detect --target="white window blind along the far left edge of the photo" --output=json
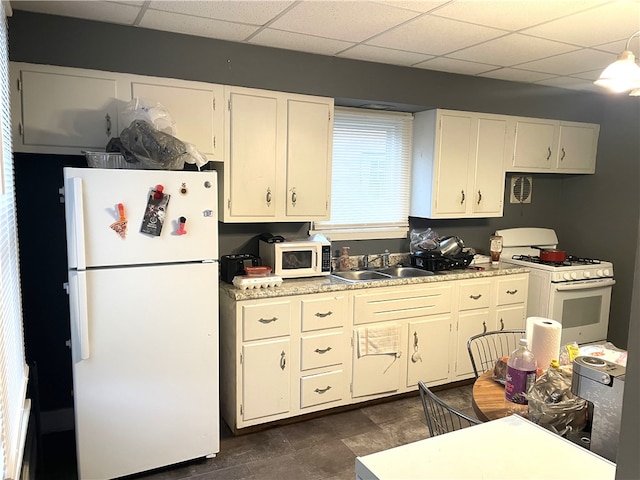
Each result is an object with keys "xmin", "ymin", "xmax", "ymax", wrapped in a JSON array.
[{"xmin": 0, "ymin": 2, "xmax": 29, "ymax": 479}]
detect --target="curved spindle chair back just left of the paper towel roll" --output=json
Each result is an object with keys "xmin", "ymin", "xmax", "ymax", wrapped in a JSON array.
[{"xmin": 467, "ymin": 330, "xmax": 526, "ymax": 378}]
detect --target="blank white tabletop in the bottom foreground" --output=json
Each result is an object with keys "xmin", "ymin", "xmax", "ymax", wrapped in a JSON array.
[{"xmin": 356, "ymin": 415, "xmax": 616, "ymax": 480}]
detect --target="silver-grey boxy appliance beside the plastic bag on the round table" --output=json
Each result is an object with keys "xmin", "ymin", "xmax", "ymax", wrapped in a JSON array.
[{"xmin": 571, "ymin": 356, "xmax": 626, "ymax": 462}]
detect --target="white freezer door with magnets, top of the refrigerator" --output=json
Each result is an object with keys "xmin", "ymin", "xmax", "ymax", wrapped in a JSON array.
[{"xmin": 64, "ymin": 168, "xmax": 218, "ymax": 269}]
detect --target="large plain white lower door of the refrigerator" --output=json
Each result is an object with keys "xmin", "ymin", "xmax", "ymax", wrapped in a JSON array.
[{"xmin": 69, "ymin": 262, "xmax": 220, "ymax": 480}]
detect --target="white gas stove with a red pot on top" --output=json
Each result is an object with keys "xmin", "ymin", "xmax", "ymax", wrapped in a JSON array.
[{"xmin": 496, "ymin": 228, "xmax": 616, "ymax": 345}]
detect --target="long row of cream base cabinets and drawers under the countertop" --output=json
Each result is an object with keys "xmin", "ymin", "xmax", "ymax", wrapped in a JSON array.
[{"xmin": 220, "ymin": 272, "xmax": 529, "ymax": 431}]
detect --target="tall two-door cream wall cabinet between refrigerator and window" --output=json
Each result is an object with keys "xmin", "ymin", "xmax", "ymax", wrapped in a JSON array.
[{"xmin": 220, "ymin": 87, "xmax": 333, "ymax": 222}]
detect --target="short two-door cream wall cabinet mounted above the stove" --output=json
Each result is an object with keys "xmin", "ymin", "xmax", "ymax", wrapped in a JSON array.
[{"xmin": 505, "ymin": 117, "xmax": 600, "ymax": 173}]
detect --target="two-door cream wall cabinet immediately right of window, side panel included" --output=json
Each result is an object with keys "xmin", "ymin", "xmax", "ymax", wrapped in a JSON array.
[{"xmin": 410, "ymin": 110, "xmax": 507, "ymax": 218}]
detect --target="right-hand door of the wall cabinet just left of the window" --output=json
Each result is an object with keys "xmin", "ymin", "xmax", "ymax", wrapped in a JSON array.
[{"xmin": 286, "ymin": 97, "xmax": 333, "ymax": 221}]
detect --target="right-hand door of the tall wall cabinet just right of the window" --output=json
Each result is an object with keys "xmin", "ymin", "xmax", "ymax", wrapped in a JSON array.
[{"xmin": 471, "ymin": 117, "xmax": 507, "ymax": 217}]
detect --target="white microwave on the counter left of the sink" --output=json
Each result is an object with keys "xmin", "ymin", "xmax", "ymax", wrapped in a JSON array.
[{"xmin": 259, "ymin": 237, "xmax": 331, "ymax": 278}]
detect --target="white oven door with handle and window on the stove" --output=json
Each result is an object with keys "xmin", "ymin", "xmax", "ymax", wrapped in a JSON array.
[{"xmin": 549, "ymin": 278, "xmax": 616, "ymax": 345}]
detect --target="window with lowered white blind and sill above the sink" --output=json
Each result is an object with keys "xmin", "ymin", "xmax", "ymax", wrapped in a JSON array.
[{"xmin": 312, "ymin": 107, "xmax": 413, "ymax": 240}]
